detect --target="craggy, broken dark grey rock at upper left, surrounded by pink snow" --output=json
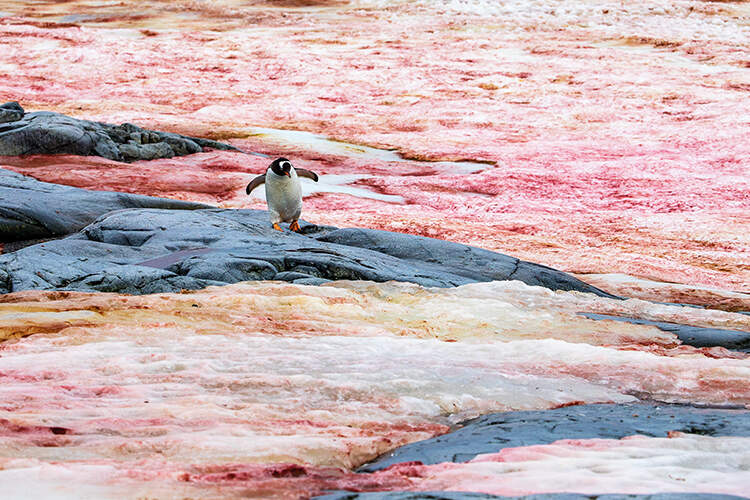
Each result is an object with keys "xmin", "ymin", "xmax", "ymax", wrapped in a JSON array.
[{"xmin": 0, "ymin": 102, "xmax": 235, "ymax": 162}]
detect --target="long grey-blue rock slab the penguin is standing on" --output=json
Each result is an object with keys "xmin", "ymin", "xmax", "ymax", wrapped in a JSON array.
[{"xmin": 0, "ymin": 199, "xmax": 607, "ymax": 296}]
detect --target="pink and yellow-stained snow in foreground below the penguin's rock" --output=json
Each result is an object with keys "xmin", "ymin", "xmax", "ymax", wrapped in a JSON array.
[{"xmin": 0, "ymin": 282, "xmax": 750, "ymax": 498}]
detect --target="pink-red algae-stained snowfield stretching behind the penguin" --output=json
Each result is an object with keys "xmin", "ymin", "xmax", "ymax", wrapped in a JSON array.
[{"xmin": 0, "ymin": 0, "xmax": 750, "ymax": 291}]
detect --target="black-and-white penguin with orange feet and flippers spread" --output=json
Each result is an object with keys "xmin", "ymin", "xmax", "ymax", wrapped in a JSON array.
[{"xmin": 245, "ymin": 158, "xmax": 318, "ymax": 233}]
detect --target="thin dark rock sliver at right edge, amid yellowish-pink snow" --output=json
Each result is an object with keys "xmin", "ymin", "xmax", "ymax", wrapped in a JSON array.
[{"xmin": 579, "ymin": 313, "xmax": 750, "ymax": 352}]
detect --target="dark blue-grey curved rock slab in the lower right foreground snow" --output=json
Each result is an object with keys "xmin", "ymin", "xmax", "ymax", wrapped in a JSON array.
[{"xmin": 359, "ymin": 403, "xmax": 750, "ymax": 472}]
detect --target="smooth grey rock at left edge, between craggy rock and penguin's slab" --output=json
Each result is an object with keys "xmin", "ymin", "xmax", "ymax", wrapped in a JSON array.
[{"xmin": 0, "ymin": 169, "xmax": 208, "ymax": 242}]
